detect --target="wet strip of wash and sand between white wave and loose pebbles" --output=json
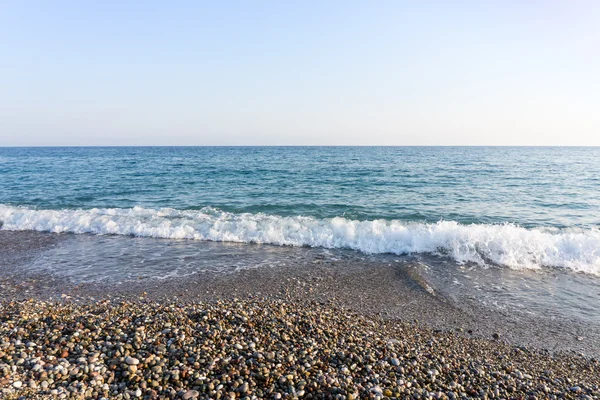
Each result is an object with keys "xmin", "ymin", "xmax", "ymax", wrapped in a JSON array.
[{"xmin": 0, "ymin": 231, "xmax": 600, "ymax": 355}]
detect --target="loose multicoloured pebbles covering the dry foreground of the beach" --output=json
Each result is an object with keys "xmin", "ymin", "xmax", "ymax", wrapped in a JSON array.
[{"xmin": 0, "ymin": 295, "xmax": 600, "ymax": 399}]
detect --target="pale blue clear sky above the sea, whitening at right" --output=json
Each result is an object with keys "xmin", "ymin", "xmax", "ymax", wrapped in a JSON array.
[{"xmin": 0, "ymin": 0, "xmax": 600, "ymax": 146}]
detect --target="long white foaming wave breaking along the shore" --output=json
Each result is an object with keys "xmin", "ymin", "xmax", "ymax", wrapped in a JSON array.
[{"xmin": 0, "ymin": 205, "xmax": 600, "ymax": 275}]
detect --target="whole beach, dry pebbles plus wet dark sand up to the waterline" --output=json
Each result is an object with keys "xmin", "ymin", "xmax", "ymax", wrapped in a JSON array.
[{"xmin": 0, "ymin": 232, "xmax": 600, "ymax": 399}]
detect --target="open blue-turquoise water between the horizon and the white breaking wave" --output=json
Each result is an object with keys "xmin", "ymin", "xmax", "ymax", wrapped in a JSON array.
[{"xmin": 0, "ymin": 147, "xmax": 600, "ymax": 228}]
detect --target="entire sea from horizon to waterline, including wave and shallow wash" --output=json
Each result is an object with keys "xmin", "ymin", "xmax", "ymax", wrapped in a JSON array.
[{"xmin": 0, "ymin": 147, "xmax": 600, "ymax": 326}]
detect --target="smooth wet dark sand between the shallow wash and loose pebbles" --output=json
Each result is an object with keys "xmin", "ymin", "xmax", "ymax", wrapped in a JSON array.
[{"xmin": 0, "ymin": 231, "xmax": 600, "ymax": 356}]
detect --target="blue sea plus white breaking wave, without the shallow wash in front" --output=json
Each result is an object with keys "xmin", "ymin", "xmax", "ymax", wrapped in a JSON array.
[{"xmin": 0, "ymin": 147, "xmax": 600, "ymax": 275}]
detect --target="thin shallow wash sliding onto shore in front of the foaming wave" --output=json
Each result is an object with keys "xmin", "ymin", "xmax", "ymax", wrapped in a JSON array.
[{"xmin": 0, "ymin": 232, "xmax": 600, "ymax": 326}]
